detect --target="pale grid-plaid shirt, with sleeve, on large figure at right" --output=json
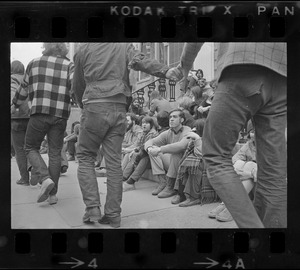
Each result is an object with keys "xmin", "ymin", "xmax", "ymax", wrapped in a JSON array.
[{"xmin": 181, "ymin": 42, "xmax": 287, "ymax": 79}]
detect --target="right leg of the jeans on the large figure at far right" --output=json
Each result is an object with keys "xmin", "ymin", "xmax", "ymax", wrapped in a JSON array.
[{"xmin": 254, "ymin": 72, "xmax": 287, "ymax": 228}]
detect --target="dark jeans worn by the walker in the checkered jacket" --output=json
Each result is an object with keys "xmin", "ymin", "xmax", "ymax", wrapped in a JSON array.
[{"xmin": 25, "ymin": 114, "xmax": 67, "ymax": 195}]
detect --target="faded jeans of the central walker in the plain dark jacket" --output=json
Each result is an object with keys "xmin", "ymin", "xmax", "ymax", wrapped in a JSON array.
[{"xmin": 77, "ymin": 103, "xmax": 127, "ymax": 217}]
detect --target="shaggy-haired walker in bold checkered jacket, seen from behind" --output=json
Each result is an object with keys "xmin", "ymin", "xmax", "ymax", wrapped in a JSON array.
[{"xmin": 11, "ymin": 43, "xmax": 73, "ymax": 204}]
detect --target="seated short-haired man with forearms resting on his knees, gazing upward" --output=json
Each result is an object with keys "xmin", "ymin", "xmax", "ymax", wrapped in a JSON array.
[{"xmin": 145, "ymin": 109, "xmax": 191, "ymax": 198}]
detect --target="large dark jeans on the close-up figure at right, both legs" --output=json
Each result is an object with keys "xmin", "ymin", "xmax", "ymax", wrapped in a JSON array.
[{"xmin": 203, "ymin": 65, "xmax": 287, "ymax": 228}]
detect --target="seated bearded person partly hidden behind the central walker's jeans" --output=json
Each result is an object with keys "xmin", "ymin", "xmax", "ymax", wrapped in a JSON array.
[{"xmin": 122, "ymin": 113, "xmax": 143, "ymax": 170}]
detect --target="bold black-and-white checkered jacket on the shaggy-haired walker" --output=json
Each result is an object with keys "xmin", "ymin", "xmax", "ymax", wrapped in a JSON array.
[{"xmin": 12, "ymin": 55, "xmax": 74, "ymax": 119}]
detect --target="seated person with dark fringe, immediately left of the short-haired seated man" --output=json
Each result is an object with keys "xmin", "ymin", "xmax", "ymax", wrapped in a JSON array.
[{"xmin": 123, "ymin": 116, "xmax": 157, "ymax": 192}]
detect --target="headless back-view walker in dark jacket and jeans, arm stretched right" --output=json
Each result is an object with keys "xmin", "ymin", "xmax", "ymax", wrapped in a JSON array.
[{"xmin": 73, "ymin": 43, "xmax": 180, "ymax": 227}]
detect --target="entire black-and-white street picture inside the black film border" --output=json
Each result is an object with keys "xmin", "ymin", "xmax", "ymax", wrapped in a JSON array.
[{"xmin": 10, "ymin": 42, "xmax": 288, "ymax": 229}]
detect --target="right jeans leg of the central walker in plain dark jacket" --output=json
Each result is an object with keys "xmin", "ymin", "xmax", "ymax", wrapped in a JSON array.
[{"xmin": 102, "ymin": 103, "xmax": 127, "ymax": 218}]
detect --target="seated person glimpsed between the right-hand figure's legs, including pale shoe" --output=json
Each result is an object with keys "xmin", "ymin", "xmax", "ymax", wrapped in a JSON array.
[{"xmin": 208, "ymin": 124, "xmax": 257, "ymax": 222}]
